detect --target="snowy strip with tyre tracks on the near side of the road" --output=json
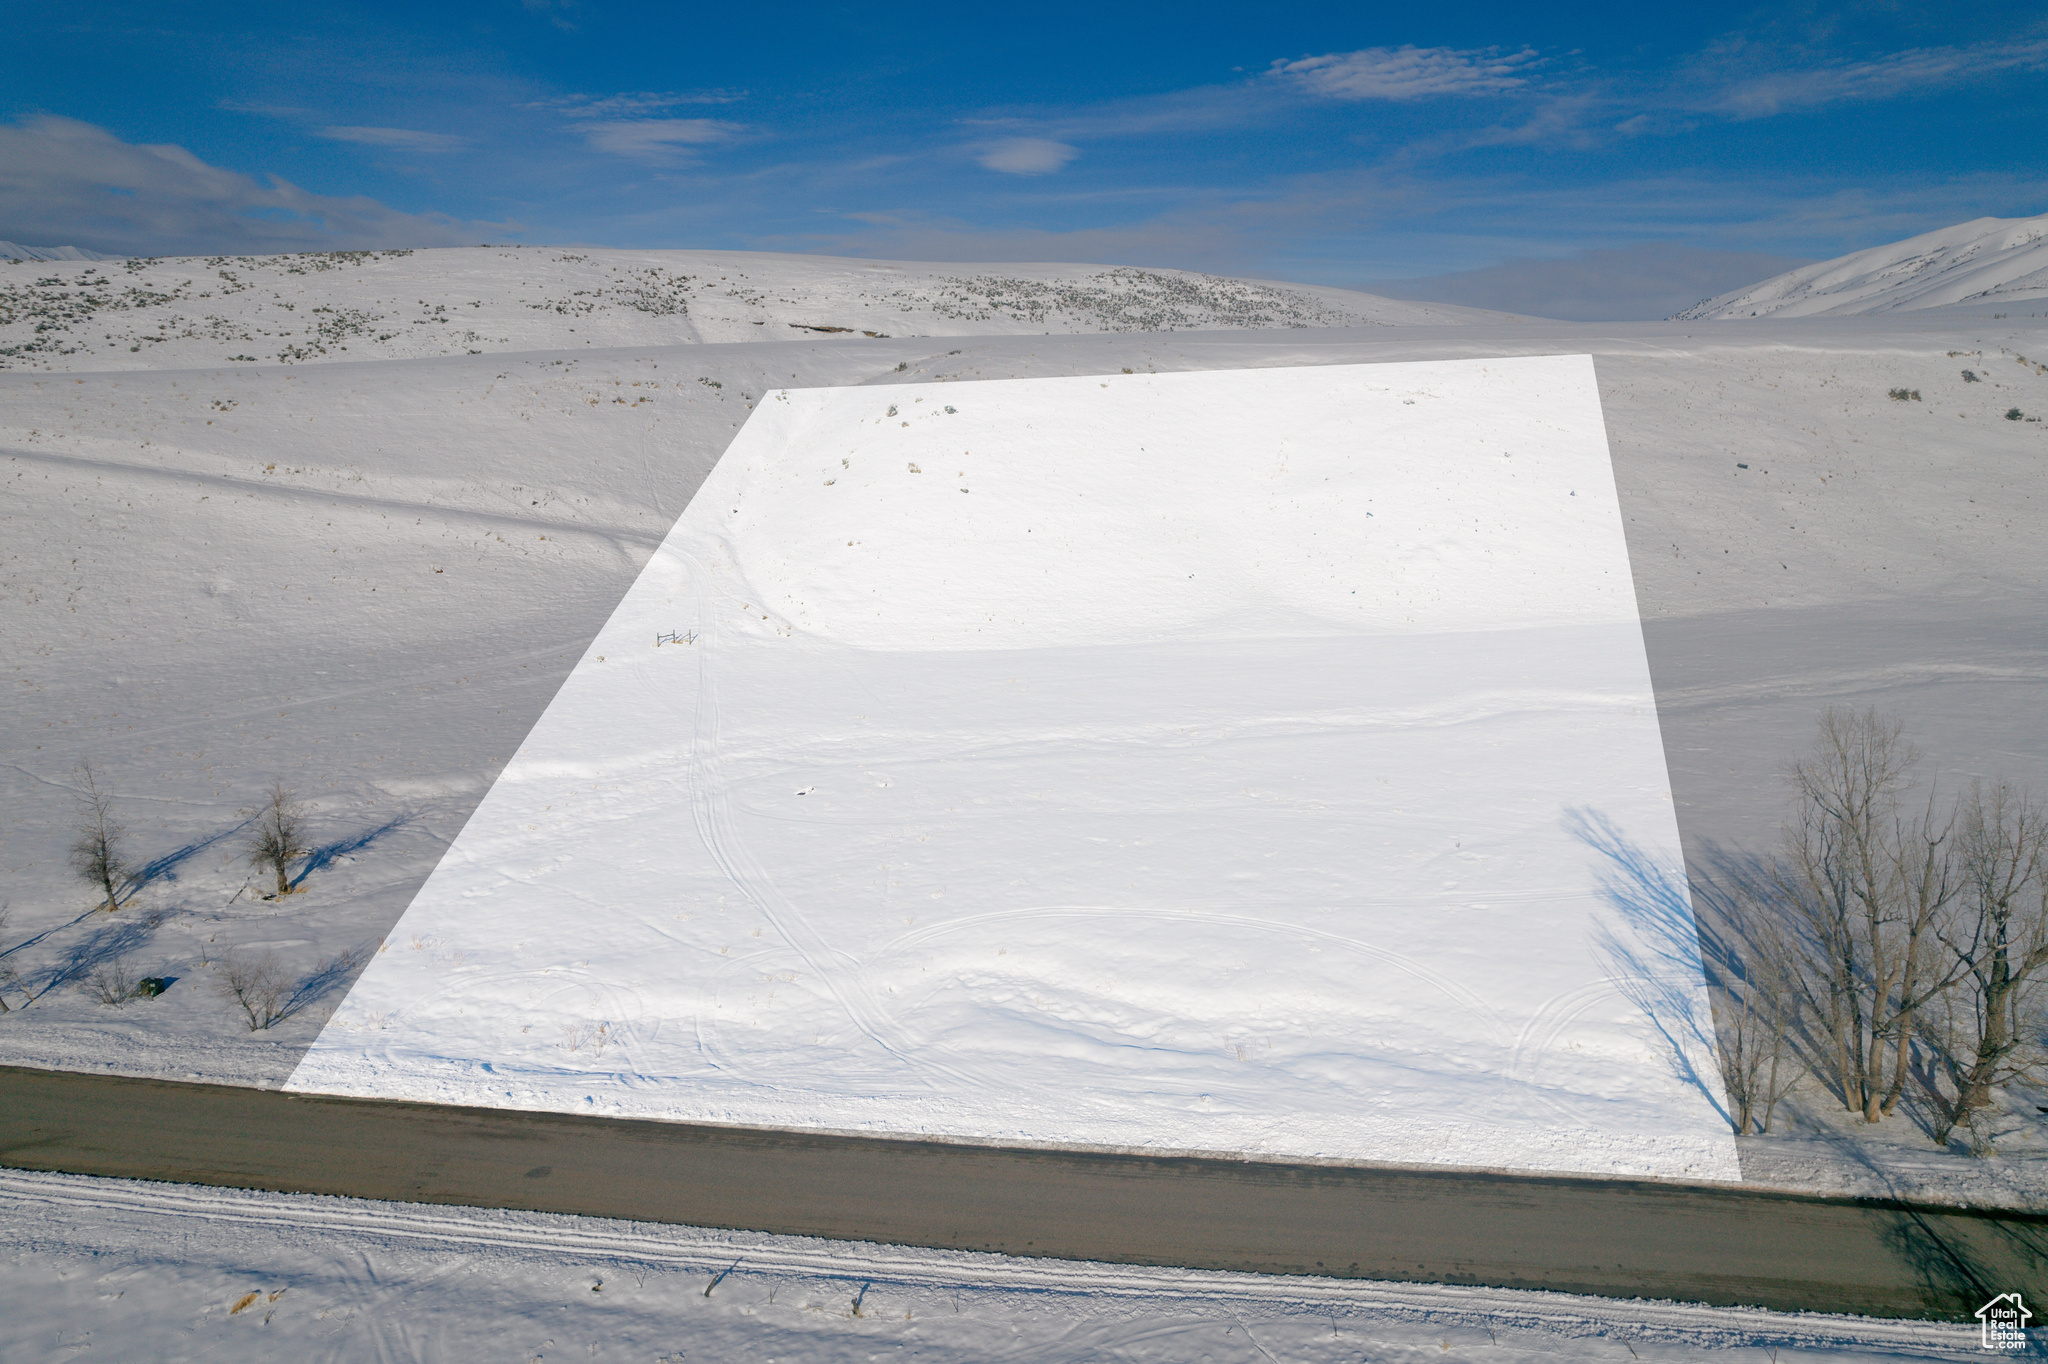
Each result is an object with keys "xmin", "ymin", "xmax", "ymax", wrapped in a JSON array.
[{"xmin": 0, "ymin": 1171, "xmax": 1985, "ymax": 1364}]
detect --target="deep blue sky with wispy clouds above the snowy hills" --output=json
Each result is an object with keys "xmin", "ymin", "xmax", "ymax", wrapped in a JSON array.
[{"xmin": 0, "ymin": 0, "xmax": 2048, "ymax": 315}]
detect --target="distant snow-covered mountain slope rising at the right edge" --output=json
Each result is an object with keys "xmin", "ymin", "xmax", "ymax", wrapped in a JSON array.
[{"xmin": 1673, "ymin": 215, "xmax": 2048, "ymax": 322}]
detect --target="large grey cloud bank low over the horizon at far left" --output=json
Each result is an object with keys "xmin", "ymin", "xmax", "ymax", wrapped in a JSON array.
[{"xmin": 0, "ymin": 117, "xmax": 477, "ymax": 256}]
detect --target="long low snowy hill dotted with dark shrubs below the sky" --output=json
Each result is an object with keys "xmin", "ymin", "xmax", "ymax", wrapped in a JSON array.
[{"xmin": 0, "ymin": 246, "xmax": 1513, "ymax": 371}]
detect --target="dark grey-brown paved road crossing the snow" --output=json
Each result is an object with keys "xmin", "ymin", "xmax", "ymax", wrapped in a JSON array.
[{"xmin": 0, "ymin": 1069, "xmax": 2048, "ymax": 1319}]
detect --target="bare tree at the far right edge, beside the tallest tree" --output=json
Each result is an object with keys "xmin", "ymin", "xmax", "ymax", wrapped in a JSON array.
[{"xmin": 1929, "ymin": 780, "xmax": 2048, "ymax": 1139}]
